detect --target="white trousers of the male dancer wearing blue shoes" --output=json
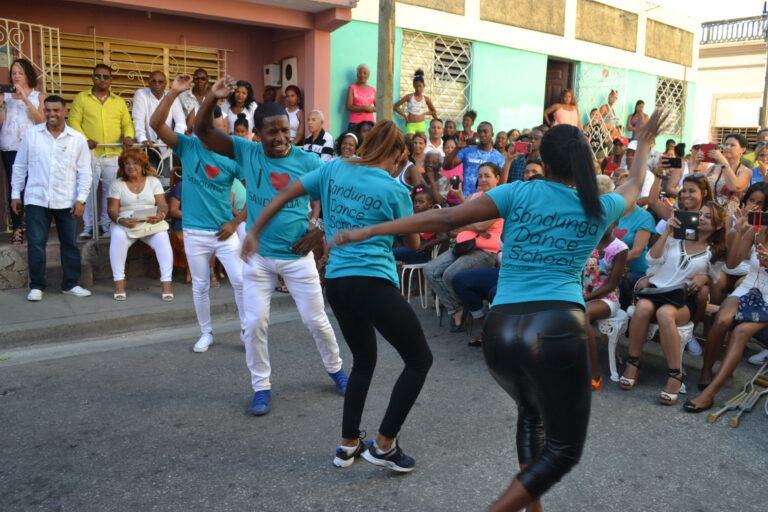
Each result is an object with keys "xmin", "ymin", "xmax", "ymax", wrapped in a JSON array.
[{"xmin": 243, "ymin": 253, "xmax": 341, "ymax": 391}]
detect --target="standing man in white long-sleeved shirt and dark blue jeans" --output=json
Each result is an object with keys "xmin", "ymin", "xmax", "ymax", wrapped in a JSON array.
[{"xmin": 11, "ymin": 95, "xmax": 92, "ymax": 301}]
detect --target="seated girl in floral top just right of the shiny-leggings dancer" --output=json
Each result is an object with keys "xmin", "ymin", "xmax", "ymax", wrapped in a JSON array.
[{"xmin": 581, "ymin": 222, "xmax": 629, "ymax": 391}]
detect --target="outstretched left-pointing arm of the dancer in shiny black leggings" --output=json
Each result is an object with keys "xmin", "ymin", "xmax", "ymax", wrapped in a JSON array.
[{"xmin": 334, "ymin": 195, "xmax": 500, "ymax": 245}]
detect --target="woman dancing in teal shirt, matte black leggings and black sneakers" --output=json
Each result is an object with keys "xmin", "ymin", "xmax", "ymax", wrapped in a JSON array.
[{"xmin": 243, "ymin": 121, "xmax": 432, "ymax": 473}]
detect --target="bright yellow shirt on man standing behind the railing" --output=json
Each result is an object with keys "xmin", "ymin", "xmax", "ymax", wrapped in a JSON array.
[{"xmin": 68, "ymin": 89, "xmax": 134, "ymax": 156}]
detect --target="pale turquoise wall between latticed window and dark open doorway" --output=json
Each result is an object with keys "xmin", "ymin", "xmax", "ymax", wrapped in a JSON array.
[{"xmin": 468, "ymin": 42, "xmax": 547, "ymax": 132}]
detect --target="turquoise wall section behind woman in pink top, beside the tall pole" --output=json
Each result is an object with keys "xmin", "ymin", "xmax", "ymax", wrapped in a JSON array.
[{"xmin": 326, "ymin": 21, "xmax": 405, "ymax": 137}]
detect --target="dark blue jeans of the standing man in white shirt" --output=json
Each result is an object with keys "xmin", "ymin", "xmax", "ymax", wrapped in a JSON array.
[{"xmin": 24, "ymin": 204, "xmax": 80, "ymax": 290}]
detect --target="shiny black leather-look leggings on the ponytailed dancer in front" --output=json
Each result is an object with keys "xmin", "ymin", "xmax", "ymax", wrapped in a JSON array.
[{"xmin": 483, "ymin": 301, "xmax": 592, "ymax": 499}]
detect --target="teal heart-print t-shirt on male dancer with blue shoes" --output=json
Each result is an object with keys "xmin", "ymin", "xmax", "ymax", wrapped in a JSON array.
[{"xmin": 232, "ymin": 137, "xmax": 323, "ymax": 260}]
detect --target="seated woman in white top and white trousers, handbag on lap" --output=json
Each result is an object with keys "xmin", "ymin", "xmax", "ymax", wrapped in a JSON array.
[{"xmin": 107, "ymin": 149, "xmax": 173, "ymax": 301}]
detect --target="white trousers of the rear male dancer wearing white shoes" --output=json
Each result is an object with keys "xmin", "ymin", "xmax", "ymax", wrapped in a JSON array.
[{"xmin": 184, "ymin": 229, "xmax": 243, "ymax": 334}]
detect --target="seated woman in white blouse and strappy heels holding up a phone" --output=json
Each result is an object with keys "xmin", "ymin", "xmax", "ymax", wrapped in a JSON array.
[{"xmin": 619, "ymin": 201, "xmax": 725, "ymax": 405}]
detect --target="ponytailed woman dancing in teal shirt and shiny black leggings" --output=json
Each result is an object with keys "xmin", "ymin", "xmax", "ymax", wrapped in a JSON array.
[{"xmin": 336, "ymin": 112, "xmax": 666, "ymax": 512}]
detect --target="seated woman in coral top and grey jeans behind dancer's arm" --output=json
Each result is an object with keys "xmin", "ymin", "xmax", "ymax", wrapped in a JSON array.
[{"xmin": 424, "ymin": 162, "xmax": 504, "ymax": 332}]
